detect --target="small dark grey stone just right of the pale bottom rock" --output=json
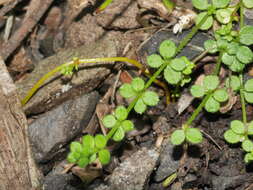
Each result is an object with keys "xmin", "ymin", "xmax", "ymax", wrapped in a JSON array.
[{"xmin": 154, "ymin": 143, "xmax": 179, "ymax": 182}]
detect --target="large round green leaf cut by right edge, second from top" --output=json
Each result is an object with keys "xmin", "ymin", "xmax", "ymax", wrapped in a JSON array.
[{"xmin": 239, "ymin": 25, "xmax": 253, "ymax": 46}]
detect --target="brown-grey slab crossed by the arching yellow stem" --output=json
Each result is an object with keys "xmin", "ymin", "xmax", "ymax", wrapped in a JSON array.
[{"xmin": 16, "ymin": 38, "xmax": 117, "ymax": 115}]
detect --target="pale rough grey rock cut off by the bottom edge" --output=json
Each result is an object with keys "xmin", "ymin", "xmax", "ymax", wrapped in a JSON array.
[{"xmin": 94, "ymin": 148, "xmax": 159, "ymax": 190}]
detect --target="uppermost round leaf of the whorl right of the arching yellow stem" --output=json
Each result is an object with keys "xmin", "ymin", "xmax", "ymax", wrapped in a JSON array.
[{"xmin": 159, "ymin": 40, "xmax": 177, "ymax": 59}]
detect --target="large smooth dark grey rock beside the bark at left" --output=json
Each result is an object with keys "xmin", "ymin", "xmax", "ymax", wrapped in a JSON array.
[{"xmin": 28, "ymin": 92, "xmax": 99, "ymax": 163}]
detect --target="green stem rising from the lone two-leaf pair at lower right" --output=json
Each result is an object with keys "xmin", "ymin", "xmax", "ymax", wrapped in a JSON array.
[{"xmin": 185, "ymin": 53, "xmax": 223, "ymax": 127}]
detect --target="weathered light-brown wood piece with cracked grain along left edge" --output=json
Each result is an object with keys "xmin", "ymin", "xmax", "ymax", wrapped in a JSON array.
[{"xmin": 0, "ymin": 59, "xmax": 40, "ymax": 190}]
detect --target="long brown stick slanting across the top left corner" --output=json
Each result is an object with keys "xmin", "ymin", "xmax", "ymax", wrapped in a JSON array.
[{"xmin": 0, "ymin": 0, "xmax": 54, "ymax": 60}]
